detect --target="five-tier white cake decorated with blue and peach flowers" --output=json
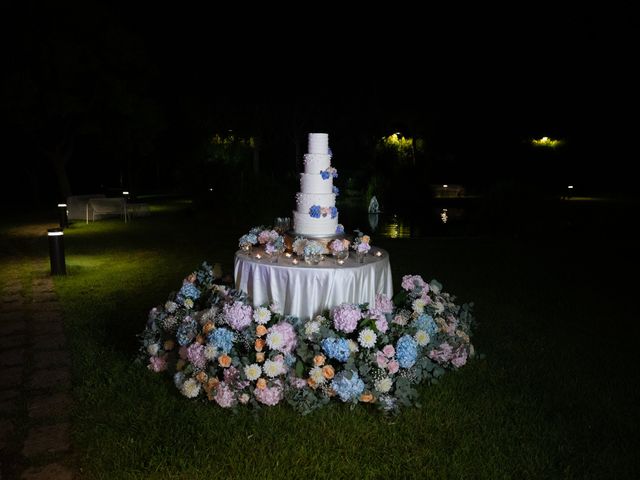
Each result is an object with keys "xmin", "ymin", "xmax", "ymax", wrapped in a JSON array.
[{"xmin": 293, "ymin": 133, "xmax": 338, "ymax": 236}]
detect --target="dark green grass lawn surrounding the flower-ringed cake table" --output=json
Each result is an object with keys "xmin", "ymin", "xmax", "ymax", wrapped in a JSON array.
[{"xmin": 0, "ymin": 197, "xmax": 640, "ymax": 479}]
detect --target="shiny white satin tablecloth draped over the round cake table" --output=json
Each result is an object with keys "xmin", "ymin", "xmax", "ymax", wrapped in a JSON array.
[{"xmin": 234, "ymin": 248, "xmax": 393, "ymax": 320}]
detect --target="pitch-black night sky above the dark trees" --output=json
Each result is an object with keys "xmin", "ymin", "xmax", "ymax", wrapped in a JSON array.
[{"xmin": 1, "ymin": 2, "xmax": 637, "ymax": 204}]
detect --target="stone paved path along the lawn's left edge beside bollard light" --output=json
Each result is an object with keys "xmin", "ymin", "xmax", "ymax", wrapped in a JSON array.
[{"xmin": 0, "ymin": 268, "xmax": 77, "ymax": 480}]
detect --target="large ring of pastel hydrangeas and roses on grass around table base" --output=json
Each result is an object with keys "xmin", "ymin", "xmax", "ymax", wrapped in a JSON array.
[{"xmin": 140, "ymin": 263, "xmax": 475, "ymax": 414}]
